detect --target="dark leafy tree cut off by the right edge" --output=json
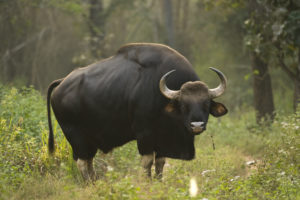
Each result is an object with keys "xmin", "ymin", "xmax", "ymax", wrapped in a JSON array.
[{"xmin": 270, "ymin": 0, "xmax": 300, "ymax": 111}]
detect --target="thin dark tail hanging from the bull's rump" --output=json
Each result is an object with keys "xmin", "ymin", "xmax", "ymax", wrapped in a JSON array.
[{"xmin": 47, "ymin": 79, "xmax": 63, "ymax": 154}]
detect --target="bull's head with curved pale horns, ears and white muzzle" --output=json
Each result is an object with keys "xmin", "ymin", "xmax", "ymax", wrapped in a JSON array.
[{"xmin": 159, "ymin": 67, "xmax": 227, "ymax": 134}]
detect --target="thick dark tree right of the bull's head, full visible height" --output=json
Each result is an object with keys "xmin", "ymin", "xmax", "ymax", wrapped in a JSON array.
[{"xmin": 245, "ymin": 1, "xmax": 275, "ymax": 123}]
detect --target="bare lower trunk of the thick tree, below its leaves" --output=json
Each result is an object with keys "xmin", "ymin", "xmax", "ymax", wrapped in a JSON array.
[{"xmin": 251, "ymin": 52, "xmax": 274, "ymax": 124}]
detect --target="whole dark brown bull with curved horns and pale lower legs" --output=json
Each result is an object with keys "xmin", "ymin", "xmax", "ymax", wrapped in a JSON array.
[{"xmin": 47, "ymin": 43, "xmax": 227, "ymax": 179}]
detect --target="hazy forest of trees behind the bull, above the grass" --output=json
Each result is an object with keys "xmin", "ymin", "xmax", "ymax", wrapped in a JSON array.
[{"xmin": 0, "ymin": 0, "xmax": 300, "ymax": 115}]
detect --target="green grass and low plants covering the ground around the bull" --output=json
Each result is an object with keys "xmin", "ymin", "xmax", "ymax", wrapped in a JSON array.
[{"xmin": 0, "ymin": 86, "xmax": 300, "ymax": 200}]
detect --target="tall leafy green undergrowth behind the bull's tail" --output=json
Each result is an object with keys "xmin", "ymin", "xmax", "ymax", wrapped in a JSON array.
[{"xmin": 0, "ymin": 85, "xmax": 72, "ymax": 198}]
